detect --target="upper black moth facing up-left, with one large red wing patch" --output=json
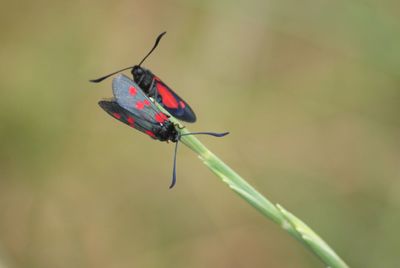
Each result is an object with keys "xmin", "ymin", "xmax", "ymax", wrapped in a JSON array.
[{"xmin": 90, "ymin": 32, "xmax": 196, "ymax": 123}]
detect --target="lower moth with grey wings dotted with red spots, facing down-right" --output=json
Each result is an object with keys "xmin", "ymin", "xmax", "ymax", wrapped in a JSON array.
[{"xmin": 99, "ymin": 75, "xmax": 228, "ymax": 188}]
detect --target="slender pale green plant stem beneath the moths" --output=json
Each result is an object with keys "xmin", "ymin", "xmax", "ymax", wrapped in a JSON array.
[{"xmin": 170, "ymin": 117, "xmax": 348, "ymax": 268}]
